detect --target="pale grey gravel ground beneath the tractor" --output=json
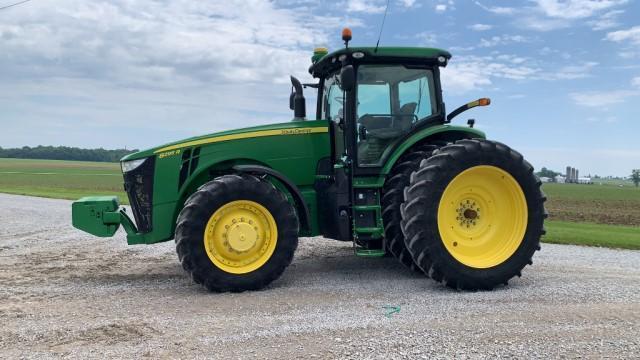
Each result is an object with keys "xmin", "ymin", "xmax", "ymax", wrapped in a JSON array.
[{"xmin": 0, "ymin": 194, "xmax": 640, "ymax": 359}]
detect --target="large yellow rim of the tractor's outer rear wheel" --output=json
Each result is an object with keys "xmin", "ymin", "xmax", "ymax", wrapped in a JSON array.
[{"xmin": 438, "ymin": 165, "xmax": 528, "ymax": 269}]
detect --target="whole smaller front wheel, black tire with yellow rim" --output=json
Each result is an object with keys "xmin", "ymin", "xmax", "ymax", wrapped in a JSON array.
[{"xmin": 176, "ymin": 175, "xmax": 299, "ymax": 292}]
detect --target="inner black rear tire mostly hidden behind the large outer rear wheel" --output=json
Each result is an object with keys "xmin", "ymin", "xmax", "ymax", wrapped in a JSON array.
[{"xmin": 381, "ymin": 143, "xmax": 444, "ymax": 272}]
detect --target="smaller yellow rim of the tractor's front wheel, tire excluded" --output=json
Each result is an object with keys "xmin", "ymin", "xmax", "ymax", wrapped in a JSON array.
[{"xmin": 204, "ymin": 200, "xmax": 278, "ymax": 274}]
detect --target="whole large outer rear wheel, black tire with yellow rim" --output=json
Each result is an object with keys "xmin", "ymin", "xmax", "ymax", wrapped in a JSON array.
[{"xmin": 401, "ymin": 140, "xmax": 546, "ymax": 290}]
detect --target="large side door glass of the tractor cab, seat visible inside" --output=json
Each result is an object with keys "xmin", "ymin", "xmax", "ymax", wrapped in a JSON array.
[{"xmin": 357, "ymin": 65, "xmax": 437, "ymax": 167}]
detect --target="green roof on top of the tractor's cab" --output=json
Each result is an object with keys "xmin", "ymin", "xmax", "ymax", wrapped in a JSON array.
[{"xmin": 309, "ymin": 47, "xmax": 451, "ymax": 77}]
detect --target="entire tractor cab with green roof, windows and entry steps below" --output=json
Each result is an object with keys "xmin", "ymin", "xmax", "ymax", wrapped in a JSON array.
[{"xmin": 290, "ymin": 33, "xmax": 472, "ymax": 256}]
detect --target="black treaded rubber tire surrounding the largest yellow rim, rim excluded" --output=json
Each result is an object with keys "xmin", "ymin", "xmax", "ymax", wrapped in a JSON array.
[{"xmin": 404, "ymin": 140, "xmax": 545, "ymax": 289}]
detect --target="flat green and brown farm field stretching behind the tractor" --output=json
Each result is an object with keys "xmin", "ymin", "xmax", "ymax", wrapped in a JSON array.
[{"xmin": 0, "ymin": 159, "xmax": 640, "ymax": 249}]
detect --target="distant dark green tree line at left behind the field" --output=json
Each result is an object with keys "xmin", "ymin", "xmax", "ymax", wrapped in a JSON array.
[{"xmin": 0, "ymin": 145, "xmax": 138, "ymax": 162}]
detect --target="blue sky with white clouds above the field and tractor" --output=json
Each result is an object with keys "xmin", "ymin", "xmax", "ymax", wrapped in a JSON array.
[{"xmin": 0, "ymin": 0, "xmax": 640, "ymax": 175}]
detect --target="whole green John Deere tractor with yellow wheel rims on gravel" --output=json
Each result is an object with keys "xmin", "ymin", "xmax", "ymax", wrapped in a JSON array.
[{"xmin": 72, "ymin": 29, "xmax": 546, "ymax": 292}]
